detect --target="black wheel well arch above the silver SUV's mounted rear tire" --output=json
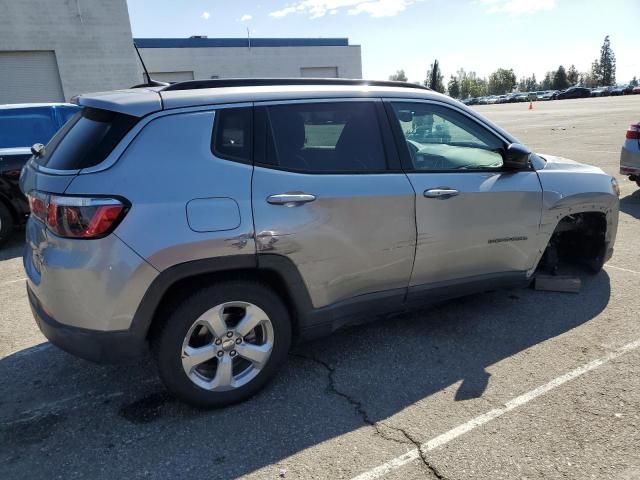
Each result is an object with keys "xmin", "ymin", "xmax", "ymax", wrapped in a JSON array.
[{"xmin": 147, "ymin": 268, "xmax": 299, "ymax": 339}]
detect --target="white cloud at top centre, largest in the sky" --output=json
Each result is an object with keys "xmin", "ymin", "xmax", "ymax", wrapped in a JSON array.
[{"xmin": 269, "ymin": 0, "xmax": 415, "ymax": 18}]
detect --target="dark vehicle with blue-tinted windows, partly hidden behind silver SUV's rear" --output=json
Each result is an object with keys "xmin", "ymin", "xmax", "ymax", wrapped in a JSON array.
[{"xmin": 0, "ymin": 103, "xmax": 79, "ymax": 245}]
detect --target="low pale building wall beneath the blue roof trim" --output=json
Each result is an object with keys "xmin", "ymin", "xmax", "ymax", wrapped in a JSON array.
[{"xmin": 140, "ymin": 45, "xmax": 362, "ymax": 80}]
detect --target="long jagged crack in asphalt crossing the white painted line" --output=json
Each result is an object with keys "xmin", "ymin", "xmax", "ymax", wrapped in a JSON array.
[{"xmin": 291, "ymin": 353, "xmax": 449, "ymax": 480}]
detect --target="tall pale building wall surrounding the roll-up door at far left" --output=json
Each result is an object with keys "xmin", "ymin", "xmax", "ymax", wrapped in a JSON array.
[{"xmin": 0, "ymin": 0, "xmax": 141, "ymax": 101}]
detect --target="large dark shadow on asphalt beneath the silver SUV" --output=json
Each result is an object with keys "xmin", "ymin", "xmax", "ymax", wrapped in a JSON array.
[{"xmin": 0, "ymin": 272, "xmax": 610, "ymax": 479}]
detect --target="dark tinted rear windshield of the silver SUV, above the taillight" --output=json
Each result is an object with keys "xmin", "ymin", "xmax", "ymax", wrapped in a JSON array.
[{"xmin": 36, "ymin": 107, "xmax": 138, "ymax": 170}]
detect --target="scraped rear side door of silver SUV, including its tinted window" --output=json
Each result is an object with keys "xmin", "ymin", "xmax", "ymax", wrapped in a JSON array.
[{"xmin": 248, "ymin": 99, "xmax": 415, "ymax": 308}]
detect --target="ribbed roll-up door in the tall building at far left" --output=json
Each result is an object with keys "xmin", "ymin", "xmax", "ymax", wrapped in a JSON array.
[{"xmin": 0, "ymin": 51, "xmax": 64, "ymax": 104}]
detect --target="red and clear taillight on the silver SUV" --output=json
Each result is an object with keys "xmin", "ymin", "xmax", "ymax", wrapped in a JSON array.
[{"xmin": 28, "ymin": 192, "xmax": 129, "ymax": 238}]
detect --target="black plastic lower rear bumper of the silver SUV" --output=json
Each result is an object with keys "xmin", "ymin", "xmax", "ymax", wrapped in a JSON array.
[{"xmin": 27, "ymin": 284, "xmax": 147, "ymax": 363}]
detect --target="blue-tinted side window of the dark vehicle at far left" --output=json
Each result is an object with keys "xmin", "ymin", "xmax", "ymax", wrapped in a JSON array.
[{"xmin": 0, "ymin": 107, "xmax": 58, "ymax": 148}]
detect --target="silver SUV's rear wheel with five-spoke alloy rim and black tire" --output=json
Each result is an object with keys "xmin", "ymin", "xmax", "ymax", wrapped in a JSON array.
[{"xmin": 151, "ymin": 280, "xmax": 291, "ymax": 408}]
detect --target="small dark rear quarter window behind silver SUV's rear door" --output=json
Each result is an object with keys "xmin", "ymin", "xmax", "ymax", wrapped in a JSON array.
[{"xmin": 212, "ymin": 108, "xmax": 253, "ymax": 162}]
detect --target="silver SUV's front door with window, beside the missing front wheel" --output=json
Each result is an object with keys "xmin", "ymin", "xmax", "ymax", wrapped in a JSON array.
[{"xmin": 387, "ymin": 101, "xmax": 542, "ymax": 286}]
